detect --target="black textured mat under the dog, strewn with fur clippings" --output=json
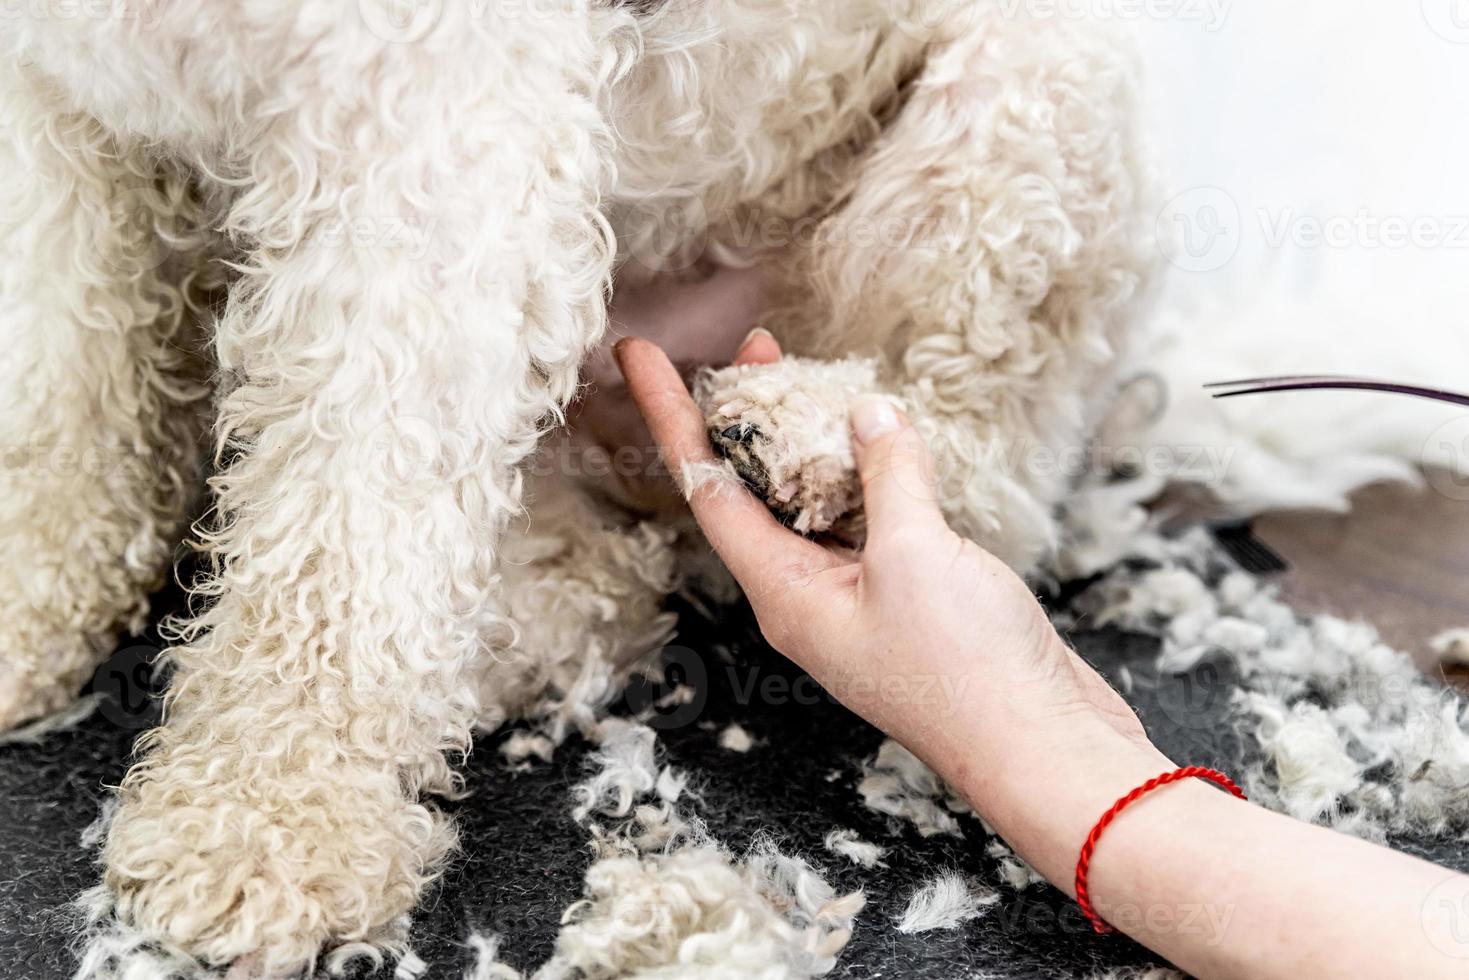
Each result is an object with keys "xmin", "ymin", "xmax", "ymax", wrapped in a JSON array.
[{"xmin": 0, "ymin": 590, "xmax": 1469, "ymax": 980}]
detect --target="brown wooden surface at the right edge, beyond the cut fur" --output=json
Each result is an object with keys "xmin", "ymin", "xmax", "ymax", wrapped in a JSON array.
[{"xmin": 1255, "ymin": 470, "xmax": 1469, "ymax": 683}]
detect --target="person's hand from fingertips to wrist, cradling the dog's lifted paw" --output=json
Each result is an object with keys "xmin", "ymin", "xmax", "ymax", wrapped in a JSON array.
[{"xmin": 616, "ymin": 339, "xmax": 1147, "ymax": 823}]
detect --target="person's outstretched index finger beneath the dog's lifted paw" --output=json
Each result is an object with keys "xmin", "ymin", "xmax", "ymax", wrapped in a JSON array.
[{"xmin": 613, "ymin": 338, "xmax": 840, "ymax": 599}]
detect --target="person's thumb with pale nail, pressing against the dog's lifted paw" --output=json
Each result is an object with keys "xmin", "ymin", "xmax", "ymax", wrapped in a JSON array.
[{"xmin": 852, "ymin": 395, "xmax": 948, "ymax": 541}]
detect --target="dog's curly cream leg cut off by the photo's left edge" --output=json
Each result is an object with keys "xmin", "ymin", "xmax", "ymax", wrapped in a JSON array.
[{"xmin": 0, "ymin": 63, "xmax": 207, "ymax": 730}]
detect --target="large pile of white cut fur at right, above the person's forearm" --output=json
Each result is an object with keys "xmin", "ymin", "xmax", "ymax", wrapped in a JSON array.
[{"xmin": 1083, "ymin": 530, "xmax": 1469, "ymax": 839}]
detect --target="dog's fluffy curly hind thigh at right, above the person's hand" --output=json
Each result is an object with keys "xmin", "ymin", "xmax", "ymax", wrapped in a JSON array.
[{"xmin": 770, "ymin": 0, "xmax": 1152, "ymax": 572}]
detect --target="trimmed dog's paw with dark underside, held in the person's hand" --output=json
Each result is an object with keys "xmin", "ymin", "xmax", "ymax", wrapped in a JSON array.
[{"xmin": 693, "ymin": 357, "xmax": 878, "ymax": 533}]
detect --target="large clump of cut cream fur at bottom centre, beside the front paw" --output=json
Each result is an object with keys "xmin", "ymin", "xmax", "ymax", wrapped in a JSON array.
[{"xmin": 540, "ymin": 718, "xmax": 865, "ymax": 980}]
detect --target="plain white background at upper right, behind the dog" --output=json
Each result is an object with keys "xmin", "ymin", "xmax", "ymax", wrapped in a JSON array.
[{"xmin": 1134, "ymin": 0, "xmax": 1469, "ymax": 359}]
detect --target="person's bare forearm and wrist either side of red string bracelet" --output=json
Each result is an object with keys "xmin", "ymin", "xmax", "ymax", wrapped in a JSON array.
[{"xmin": 961, "ymin": 723, "xmax": 1469, "ymax": 980}]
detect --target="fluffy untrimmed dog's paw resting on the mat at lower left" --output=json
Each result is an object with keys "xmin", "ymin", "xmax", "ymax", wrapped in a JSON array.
[{"xmin": 103, "ymin": 745, "xmax": 454, "ymax": 977}]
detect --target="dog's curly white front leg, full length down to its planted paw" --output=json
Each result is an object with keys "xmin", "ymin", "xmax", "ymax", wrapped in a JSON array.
[{"xmin": 96, "ymin": 4, "xmax": 611, "ymax": 977}]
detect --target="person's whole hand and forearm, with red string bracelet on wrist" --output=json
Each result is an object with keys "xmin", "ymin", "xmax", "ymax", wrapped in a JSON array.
[{"xmin": 616, "ymin": 334, "xmax": 1469, "ymax": 979}]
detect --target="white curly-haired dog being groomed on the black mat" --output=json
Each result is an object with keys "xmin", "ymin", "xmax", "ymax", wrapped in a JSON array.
[{"xmin": 0, "ymin": 0, "xmax": 1147, "ymax": 976}]
